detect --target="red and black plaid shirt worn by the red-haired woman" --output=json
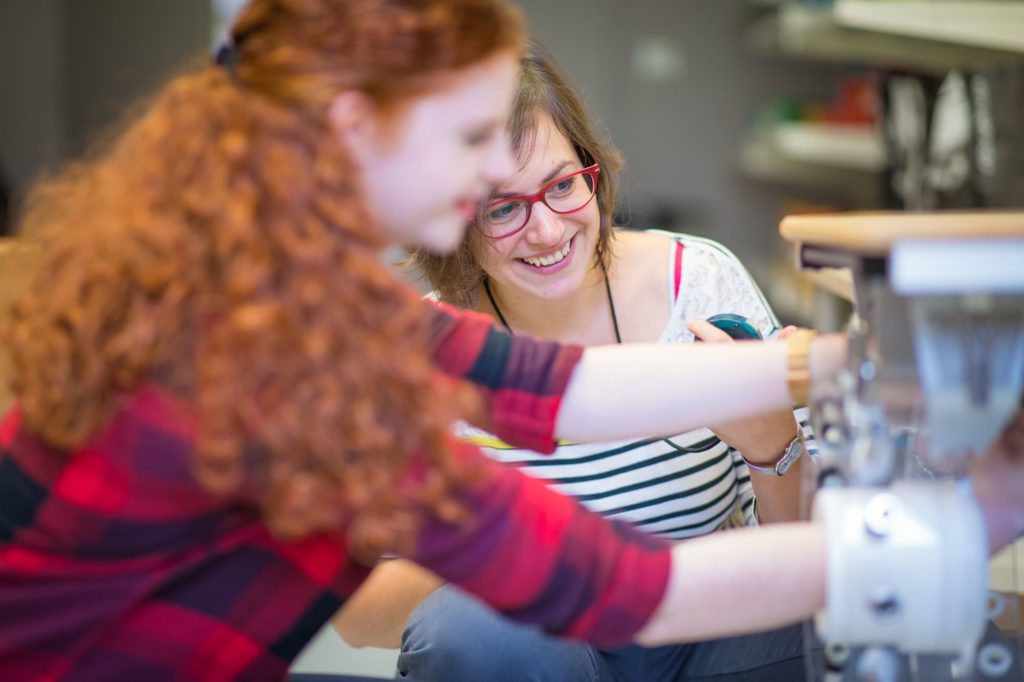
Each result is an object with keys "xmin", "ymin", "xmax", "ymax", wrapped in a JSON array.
[{"xmin": 0, "ymin": 309, "xmax": 670, "ymax": 682}]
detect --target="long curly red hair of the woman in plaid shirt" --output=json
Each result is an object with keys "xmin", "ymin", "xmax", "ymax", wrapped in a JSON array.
[{"xmin": 4, "ymin": 0, "xmax": 521, "ymax": 550}]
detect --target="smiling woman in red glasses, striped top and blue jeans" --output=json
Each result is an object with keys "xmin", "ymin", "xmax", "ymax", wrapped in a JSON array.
[{"xmin": 336, "ymin": 45, "xmax": 805, "ymax": 682}]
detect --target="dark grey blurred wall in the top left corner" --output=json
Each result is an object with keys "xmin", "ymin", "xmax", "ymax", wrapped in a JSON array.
[{"xmin": 0, "ymin": 0, "xmax": 211, "ymax": 200}]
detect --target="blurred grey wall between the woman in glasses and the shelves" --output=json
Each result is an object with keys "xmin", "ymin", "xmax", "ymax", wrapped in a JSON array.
[{"xmin": 518, "ymin": 0, "xmax": 836, "ymax": 269}]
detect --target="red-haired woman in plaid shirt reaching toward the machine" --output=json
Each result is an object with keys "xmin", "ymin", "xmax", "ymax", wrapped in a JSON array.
[{"xmin": 0, "ymin": 0, "xmax": 1019, "ymax": 680}]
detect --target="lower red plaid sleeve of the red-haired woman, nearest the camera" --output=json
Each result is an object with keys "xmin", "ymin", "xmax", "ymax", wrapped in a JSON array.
[{"xmin": 410, "ymin": 441, "xmax": 672, "ymax": 647}]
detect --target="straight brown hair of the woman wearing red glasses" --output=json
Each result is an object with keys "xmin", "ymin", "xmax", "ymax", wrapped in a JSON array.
[{"xmin": 412, "ymin": 40, "xmax": 623, "ymax": 308}]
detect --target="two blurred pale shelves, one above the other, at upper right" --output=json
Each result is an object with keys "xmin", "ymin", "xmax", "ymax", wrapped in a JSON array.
[{"xmin": 739, "ymin": 0, "xmax": 1024, "ymax": 201}]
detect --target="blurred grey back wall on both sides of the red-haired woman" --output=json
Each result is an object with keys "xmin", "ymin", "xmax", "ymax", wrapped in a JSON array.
[{"xmin": 0, "ymin": 0, "xmax": 835, "ymax": 276}]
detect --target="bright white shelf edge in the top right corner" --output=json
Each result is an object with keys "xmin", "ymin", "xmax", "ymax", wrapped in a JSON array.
[{"xmin": 835, "ymin": 0, "xmax": 1024, "ymax": 54}]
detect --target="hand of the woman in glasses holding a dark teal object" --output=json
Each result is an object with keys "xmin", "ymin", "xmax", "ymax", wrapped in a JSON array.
[{"xmin": 686, "ymin": 319, "xmax": 798, "ymax": 466}]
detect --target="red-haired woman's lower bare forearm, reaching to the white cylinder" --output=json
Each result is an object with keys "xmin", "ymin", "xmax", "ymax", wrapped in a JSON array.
[{"xmin": 636, "ymin": 523, "xmax": 825, "ymax": 646}]
